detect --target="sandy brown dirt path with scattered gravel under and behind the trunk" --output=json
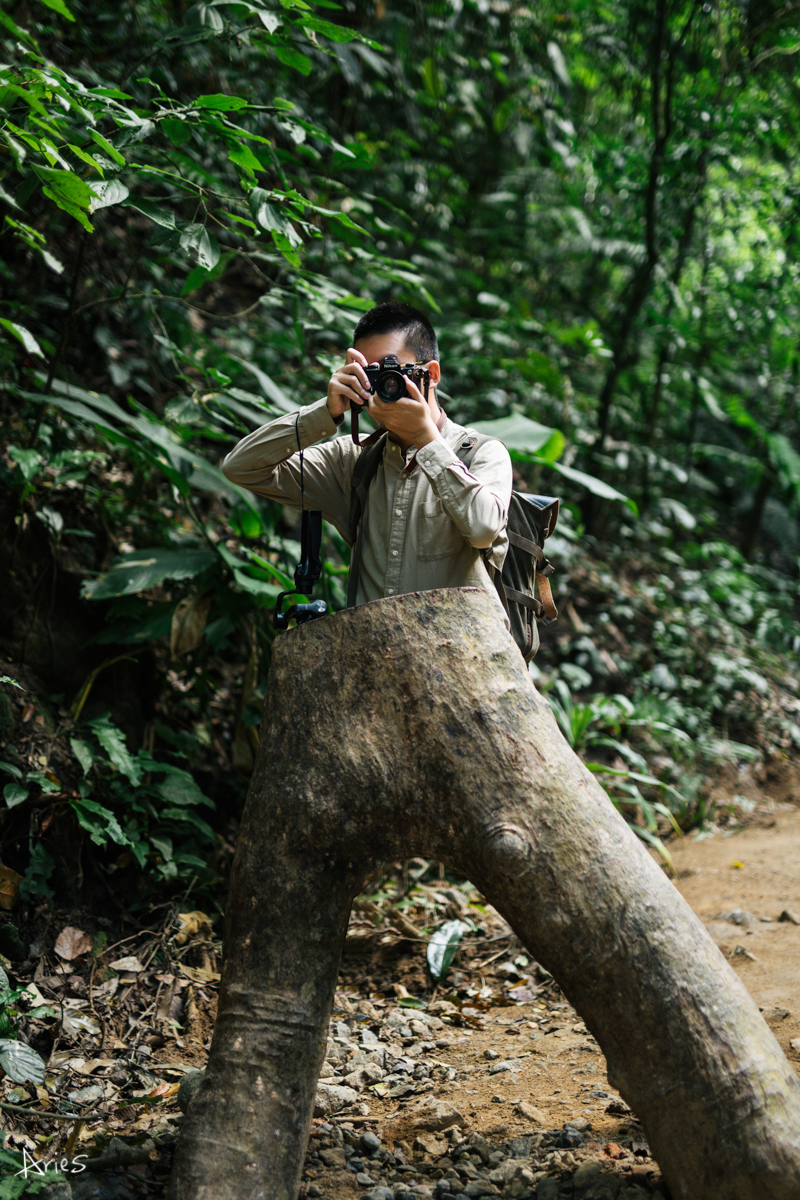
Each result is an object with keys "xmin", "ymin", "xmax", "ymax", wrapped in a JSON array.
[{"xmin": 298, "ymin": 805, "xmax": 800, "ymax": 1200}]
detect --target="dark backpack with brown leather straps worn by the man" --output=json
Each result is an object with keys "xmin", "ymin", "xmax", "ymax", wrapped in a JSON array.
[{"xmin": 347, "ymin": 430, "xmax": 559, "ymax": 662}]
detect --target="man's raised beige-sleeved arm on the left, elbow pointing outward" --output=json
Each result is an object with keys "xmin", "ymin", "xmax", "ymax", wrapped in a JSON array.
[{"xmin": 222, "ymin": 400, "xmax": 353, "ymax": 539}]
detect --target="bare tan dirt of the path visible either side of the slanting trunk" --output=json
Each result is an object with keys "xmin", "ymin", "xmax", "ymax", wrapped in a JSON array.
[{"xmin": 323, "ymin": 803, "xmax": 800, "ymax": 1195}]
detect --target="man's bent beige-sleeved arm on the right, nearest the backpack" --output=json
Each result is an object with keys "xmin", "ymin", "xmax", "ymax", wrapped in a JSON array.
[{"xmin": 416, "ymin": 438, "xmax": 512, "ymax": 550}]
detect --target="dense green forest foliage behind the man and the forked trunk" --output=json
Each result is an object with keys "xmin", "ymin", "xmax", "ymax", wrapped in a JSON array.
[{"xmin": 0, "ymin": 0, "xmax": 800, "ymax": 1195}]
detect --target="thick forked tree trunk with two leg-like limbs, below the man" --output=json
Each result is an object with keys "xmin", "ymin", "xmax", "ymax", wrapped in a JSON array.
[{"xmin": 170, "ymin": 589, "xmax": 800, "ymax": 1200}]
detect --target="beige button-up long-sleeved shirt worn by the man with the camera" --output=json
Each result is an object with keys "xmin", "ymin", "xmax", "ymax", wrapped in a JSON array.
[{"xmin": 222, "ymin": 400, "xmax": 512, "ymax": 620}]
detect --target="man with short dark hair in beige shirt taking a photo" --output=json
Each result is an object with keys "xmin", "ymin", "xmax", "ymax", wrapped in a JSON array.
[{"xmin": 222, "ymin": 301, "xmax": 512, "ymax": 620}]
